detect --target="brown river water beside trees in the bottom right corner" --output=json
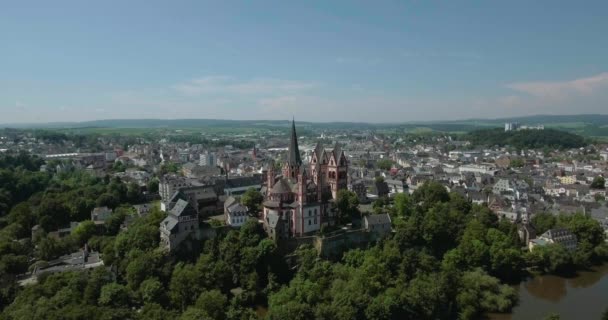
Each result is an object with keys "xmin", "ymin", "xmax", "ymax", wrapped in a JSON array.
[{"xmin": 488, "ymin": 264, "xmax": 608, "ymax": 320}]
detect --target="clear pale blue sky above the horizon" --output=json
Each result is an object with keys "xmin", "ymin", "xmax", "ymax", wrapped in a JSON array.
[{"xmin": 0, "ymin": 0, "xmax": 608, "ymax": 123}]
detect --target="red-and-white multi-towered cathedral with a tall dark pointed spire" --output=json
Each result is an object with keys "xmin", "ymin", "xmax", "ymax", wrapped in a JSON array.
[{"xmin": 263, "ymin": 121, "xmax": 348, "ymax": 240}]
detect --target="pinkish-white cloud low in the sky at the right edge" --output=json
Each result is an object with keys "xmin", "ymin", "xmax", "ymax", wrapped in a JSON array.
[{"xmin": 507, "ymin": 72, "xmax": 608, "ymax": 100}]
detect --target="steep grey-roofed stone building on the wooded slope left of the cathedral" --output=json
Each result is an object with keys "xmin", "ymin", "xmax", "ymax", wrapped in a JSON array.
[{"xmin": 159, "ymin": 192, "xmax": 199, "ymax": 252}]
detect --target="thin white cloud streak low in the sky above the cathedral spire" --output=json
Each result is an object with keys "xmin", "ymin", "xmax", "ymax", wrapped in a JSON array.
[{"xmin": 172, "ymin": 76, "xmax": 318, "ymax": 96}]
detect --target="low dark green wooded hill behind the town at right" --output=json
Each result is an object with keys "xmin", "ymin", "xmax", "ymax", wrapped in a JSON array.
[{"xmin": 464, "ymin": 128, "xmax": 586, "ymax": 149}]
